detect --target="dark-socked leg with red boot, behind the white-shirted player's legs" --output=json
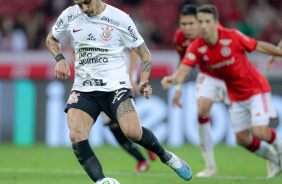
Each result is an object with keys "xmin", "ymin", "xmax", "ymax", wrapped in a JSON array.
[{"xmin": 101, "ymin": 112, "xmax": 150, "ymax": 172}]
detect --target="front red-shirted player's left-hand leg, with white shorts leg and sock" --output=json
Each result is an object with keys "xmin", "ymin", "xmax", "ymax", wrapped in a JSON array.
[{"xmin": 229, "ymin": 98, "xmax": 279, "ymax": 178}]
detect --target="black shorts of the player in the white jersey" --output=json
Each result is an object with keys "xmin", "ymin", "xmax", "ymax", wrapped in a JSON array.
[{"xmin": 65, "ymin": 88, "xmax": 133, "ymax": 122}]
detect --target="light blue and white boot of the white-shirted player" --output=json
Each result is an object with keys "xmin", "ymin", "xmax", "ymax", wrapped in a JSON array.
[{"xmin": 166, "ymin": 153, "xmax": 192, "ymax": 181}]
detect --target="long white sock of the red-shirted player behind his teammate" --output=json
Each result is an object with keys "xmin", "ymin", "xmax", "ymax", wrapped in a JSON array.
[{"xmin": 199, "ymin": 122, "xmax": 216, "ymax": 168}]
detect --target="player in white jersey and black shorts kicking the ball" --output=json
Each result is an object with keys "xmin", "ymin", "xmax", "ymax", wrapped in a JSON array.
[{"xmin": 46, "ymin": 0, "xmax": 192, "ymax": 182}]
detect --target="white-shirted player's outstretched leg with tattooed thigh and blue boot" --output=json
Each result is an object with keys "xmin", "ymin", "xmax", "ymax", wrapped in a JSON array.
[{"xmin": 116, "ymin": 98, "xmax": 192, "ymax": 180}]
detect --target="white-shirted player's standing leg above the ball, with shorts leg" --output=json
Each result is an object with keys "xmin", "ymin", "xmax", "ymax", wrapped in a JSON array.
[{"xmin": 65, "ymin": 92, "xmax": 105, "ymax": 182}]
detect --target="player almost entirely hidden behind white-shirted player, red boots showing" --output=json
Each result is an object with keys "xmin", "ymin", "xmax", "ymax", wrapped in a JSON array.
[{"xmin": 73, "ymin": 50, "xmax": 157, "ymax": 172}]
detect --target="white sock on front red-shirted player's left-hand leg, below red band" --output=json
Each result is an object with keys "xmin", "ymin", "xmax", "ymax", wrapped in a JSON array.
[{"xmin": 255, "ymin": 141, "xmax": 279, "ymax": 164}]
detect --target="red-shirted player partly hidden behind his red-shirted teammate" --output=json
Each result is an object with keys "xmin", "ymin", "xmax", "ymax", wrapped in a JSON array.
[{"xmin": 172, "ymin": 5, "xmax": 229, "ymax": 177}]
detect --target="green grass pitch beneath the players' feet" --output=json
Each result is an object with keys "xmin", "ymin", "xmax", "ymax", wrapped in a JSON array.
[{"xmin": 0, "ymin": 144, "xmax": 282, "ymax": 184}]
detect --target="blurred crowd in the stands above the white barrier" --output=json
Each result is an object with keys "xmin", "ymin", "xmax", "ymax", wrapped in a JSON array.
[{"xmin": 0, "ymin": 0, "xmax": 282, "ymax": 52}]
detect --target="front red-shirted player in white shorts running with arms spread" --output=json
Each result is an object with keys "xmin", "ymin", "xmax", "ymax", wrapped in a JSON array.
[{"xmin": 162, "ymin": 5, "xmax": 282, "ymax": 177}]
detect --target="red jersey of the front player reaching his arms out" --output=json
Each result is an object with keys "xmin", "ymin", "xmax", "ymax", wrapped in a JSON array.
[{"xmin": 182, "ymin": 28, "xmax": 271, "ymax": 101}]
